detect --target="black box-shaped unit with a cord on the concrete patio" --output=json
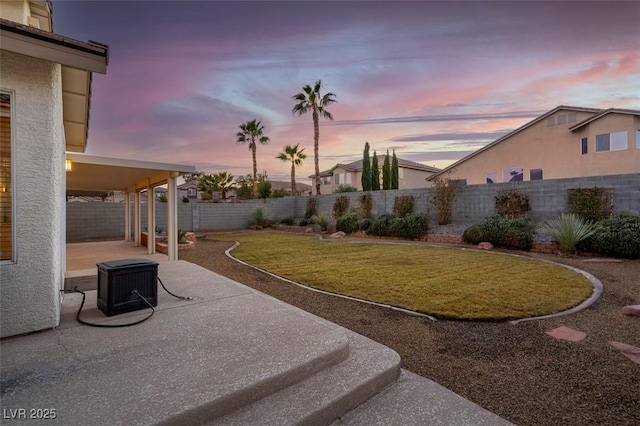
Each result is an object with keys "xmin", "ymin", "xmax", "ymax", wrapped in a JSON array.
[{"xmin": 96, "ymin": 259, "xmax": 158, "ymax": 317}]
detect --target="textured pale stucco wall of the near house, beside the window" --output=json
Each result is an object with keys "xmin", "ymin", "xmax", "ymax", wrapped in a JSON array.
[{"xmin": 0, "ymin": 51, "xmax": 64, "ymax": 337}]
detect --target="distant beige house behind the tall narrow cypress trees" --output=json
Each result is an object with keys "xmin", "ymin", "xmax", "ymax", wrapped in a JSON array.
[{"xmin": 309, "ymin": 155, "xmax": 440, "ymax": 194}]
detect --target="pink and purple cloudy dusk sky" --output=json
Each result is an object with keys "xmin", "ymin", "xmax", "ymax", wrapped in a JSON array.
[{"xmin": 53, "ymin": 0, "xmax": 640, "ymax": 183}]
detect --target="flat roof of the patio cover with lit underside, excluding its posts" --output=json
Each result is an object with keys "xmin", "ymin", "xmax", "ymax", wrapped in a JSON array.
[{"xmin": 66, "ymin": 152, "xmax": 196, "ymax": 192}]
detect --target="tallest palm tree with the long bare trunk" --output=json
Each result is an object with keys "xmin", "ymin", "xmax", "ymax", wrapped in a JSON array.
[{"xmin": 291, "ymin": 80, "xmax": 337, "ymax": 195}]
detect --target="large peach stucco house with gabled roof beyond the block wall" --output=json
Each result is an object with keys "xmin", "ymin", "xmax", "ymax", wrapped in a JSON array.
[{"xmin": 430, "ymin": 106, "xmax": 640, "ymax": 185}]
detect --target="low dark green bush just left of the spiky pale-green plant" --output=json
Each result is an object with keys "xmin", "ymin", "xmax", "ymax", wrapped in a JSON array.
[{"xmin": 462, "ymin": 215, "xmax": 533, "ymax": 250}]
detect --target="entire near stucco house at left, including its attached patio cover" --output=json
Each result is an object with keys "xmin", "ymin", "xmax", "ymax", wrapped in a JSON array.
[{"xmin": 0, "ymin": 0, "xmax": 195, "ymax": 337}]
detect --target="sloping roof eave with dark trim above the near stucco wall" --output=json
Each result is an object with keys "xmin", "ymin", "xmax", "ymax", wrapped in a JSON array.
[{"xmin": 0, "ymin": 19, "xmax": 109, "ymax": 152}]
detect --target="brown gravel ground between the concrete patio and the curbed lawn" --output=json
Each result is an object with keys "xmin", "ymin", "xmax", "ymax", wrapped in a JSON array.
[{"xmin": 180, "ymin": 235, "xmax": 640, "ymax": 425}]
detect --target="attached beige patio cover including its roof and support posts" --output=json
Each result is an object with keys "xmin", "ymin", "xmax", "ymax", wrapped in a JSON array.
[{"xmin": 66, "ymin": 152, "xmax": 195, "ymax": 260}]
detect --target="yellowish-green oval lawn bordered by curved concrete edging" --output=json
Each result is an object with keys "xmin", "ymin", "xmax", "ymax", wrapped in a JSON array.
[{"xmin": 215, "ymin": 231, "xmax": 592, "ymax": 320}]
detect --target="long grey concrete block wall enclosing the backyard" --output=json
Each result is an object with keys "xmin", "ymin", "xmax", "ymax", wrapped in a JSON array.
[{"xmin": 67, "ymin": 173, "xmax": 640, "ymax": 241}]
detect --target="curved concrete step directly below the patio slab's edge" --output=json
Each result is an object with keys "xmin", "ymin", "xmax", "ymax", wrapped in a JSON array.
[{"xmin": 207, "ymin": 330, "xmax": 401, "ymax": 425}]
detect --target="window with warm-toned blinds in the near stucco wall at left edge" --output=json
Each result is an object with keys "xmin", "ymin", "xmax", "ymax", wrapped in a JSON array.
[{"xmin": 0, "ymin": 91, "xmax": 15, "ymax": 262}]
